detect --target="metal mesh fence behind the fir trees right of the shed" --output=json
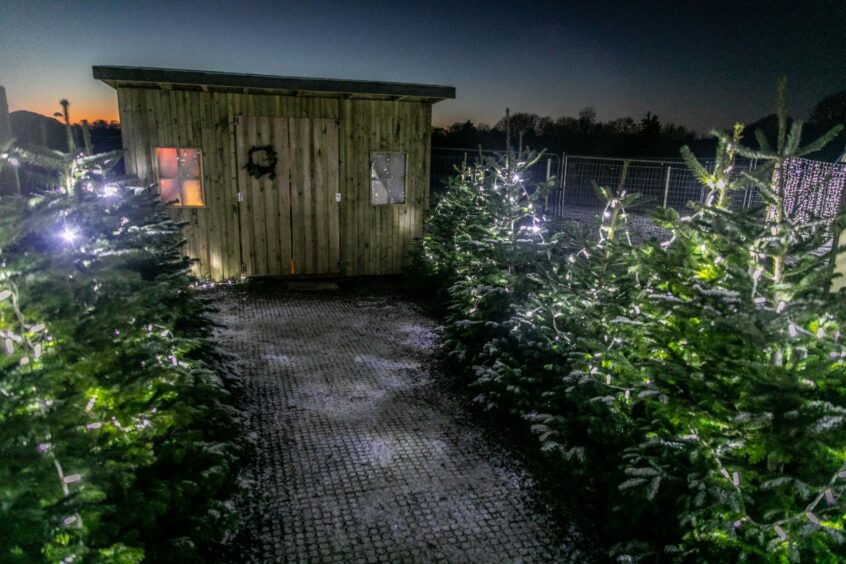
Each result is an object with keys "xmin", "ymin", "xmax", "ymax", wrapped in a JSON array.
[{"xmin": 431, "ymin": 148, "xmax": 846, "ymax": 230}]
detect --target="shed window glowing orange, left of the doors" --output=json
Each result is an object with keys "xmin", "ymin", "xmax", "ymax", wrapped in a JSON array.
[{"xmin": 156, "ymin": 147, "xmax": 205, "ymax": 207}]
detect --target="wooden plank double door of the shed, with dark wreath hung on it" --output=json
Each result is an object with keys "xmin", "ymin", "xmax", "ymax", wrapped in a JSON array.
[{"xmin": 235, "ymin": 117, "xmax": 340, "ymax": 276}]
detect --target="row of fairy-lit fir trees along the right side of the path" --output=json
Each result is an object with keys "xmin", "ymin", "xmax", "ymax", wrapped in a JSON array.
[{"xmin": 421, "ymin": 85, "xmax": 846, "ymax": 562}]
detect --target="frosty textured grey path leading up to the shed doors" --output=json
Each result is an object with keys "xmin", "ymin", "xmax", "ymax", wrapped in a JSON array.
[{"xmin": 212, "ymin": 287, "xmax": 589, "ymax": 562}]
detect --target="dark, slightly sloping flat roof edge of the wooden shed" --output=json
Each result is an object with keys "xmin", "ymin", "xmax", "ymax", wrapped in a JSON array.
[{"xmin": 92, "ymin": 66, "xmax": 455, "ymax": 103}]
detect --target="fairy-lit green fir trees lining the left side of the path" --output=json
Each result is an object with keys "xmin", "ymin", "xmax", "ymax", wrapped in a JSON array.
[{"xmin": 0, "ymin": 105, "xmax": 246, "ymax": 562}]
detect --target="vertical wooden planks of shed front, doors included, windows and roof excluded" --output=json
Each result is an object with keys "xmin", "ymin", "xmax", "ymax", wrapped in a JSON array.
[{"xmin": 117, "ymin": 86, "xmax": 432, "ymax": 280}]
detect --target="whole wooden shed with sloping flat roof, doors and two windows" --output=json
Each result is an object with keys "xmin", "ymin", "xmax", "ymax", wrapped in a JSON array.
[{"xmin": 93, "ymin": 66, "xmax": 455, "ymax": 280}]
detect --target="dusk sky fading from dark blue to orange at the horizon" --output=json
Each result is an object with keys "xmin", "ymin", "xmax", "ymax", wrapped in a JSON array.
[{"xmin": 0, "ymin": 0, "xmax": 846, "ymax": 133}]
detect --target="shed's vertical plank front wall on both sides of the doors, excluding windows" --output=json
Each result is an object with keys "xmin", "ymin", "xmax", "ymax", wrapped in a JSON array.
[{"xmin": 117, "ymin": 87, "xmax": 432, "ymax": 280}]
